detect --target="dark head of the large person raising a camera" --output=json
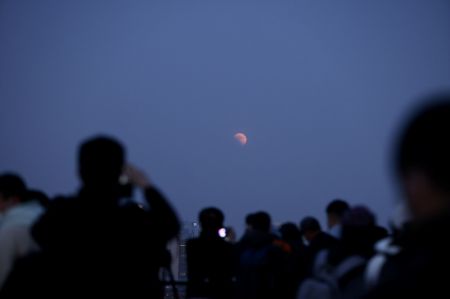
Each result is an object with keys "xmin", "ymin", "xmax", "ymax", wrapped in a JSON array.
[{"xmin": 78, "ymin": 136, "xmax": 125, "ymax": 188}]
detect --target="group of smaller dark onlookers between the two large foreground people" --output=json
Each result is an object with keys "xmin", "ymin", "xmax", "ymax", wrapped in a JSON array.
[{"xmin": 186, "ymin": 199, "xmax": 389, "ymax": 299}]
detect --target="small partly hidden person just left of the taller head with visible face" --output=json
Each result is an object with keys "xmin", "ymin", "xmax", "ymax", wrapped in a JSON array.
[{"xmin": 300, "ymin": 216, "xmax": 337, "ymax": 275}]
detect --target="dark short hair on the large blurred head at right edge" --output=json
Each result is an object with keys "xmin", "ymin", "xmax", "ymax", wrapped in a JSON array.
[{"xmin": 395, "ymin": 94, "xmax": 450, "ymax": 192}]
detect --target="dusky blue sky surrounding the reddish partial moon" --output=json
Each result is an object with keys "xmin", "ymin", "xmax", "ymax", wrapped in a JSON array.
[{"xmin": 0, "ymin": 0, "xmax": 450, "ymax": 239}]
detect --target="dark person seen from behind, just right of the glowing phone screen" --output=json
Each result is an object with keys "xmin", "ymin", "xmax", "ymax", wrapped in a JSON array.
[{"xmin": 236, "ymin": 211, "xmax": 289, "ymax": 299}]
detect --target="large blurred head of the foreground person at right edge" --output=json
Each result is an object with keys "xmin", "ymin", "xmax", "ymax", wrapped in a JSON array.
[{"xmin": 395, "ymin": 94, "xmax": 450, "ymax": 219}]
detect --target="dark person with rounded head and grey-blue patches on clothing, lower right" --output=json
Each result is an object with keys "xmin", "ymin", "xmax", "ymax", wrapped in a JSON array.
[{"xmin": 298, "ymin": 206, "xmax": 377, "ymax": 299}]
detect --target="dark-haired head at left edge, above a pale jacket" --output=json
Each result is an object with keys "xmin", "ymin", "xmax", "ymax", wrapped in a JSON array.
[{"xmin": 0, "ymin": 173, "xmax": 27, "ymax": 212}]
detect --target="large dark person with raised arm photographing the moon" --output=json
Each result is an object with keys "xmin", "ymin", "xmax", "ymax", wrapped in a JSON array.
[{"xmin": 3, "ymin": 137, "xmax": 179, "ymax": 298}]
